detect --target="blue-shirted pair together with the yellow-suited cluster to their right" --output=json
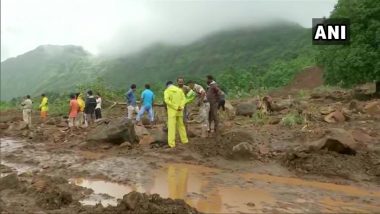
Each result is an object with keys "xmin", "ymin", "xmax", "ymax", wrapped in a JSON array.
[{"xmin": 125, "ymin": 75, "xmax": 225, "ymax": 147}]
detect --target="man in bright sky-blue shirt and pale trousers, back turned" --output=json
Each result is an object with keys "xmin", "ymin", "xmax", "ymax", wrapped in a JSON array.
[{"xmin": 136, "ymin": 84, "xmax": 154, "ymax": 125}]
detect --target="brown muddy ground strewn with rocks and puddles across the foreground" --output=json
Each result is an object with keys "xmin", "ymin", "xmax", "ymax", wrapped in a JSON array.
[{"xmin": 0, "ymin": 83, "xmax": 380, "ymax": 213}]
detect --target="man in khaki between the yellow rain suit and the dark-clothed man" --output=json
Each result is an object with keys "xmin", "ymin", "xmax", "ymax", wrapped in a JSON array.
[{"xmin": 188, "ymin": 80, "xmax": 210, "ymax": 137}]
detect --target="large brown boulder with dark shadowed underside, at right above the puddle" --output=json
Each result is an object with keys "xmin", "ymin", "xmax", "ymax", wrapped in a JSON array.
[{"xmin": 308, "ymin": 128, "xmax": 365, "ymax": 155}]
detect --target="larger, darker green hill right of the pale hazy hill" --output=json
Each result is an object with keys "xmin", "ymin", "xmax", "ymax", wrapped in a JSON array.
[{"xmin": 101, "ymin": 24, "xmax": 311, "ymax": 86}]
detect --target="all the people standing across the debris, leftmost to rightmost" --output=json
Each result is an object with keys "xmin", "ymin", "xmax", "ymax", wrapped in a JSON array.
[{"xmin": 21, "ymin": 75, "xmax": 225, "ymax": 147}]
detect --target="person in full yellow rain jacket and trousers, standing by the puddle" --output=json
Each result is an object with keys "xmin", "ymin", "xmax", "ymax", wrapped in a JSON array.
[{"xmin": 164, "ymin": 81, "xmax": 189, "ymax": 148}]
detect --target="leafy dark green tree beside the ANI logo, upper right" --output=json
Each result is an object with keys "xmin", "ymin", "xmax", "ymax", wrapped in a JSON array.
[{"xmin": 317, "ymin": 0, "xmax": 380, "ymax": 93}]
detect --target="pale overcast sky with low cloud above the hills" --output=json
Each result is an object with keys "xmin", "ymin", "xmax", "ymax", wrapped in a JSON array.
[{"xmin": 1, "ymin": 0, "xmax": 337, "ymax": 61}]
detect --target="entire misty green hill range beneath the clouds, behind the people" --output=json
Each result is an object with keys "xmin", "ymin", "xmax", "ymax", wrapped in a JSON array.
[{"xmin": 1, "ymin": 23, "xmax": 311, "ymax": 99}]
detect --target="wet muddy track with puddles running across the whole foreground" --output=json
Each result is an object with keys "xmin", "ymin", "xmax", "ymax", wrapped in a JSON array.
[{"xmin": 1, "ymin": 138, "xmax": 380, "ymax": 213}]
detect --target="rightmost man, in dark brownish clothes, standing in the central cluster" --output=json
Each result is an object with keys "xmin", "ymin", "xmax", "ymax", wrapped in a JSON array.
[{"xmin": 206, "ymin": 75, "xmax": 222, "ymax": 135}]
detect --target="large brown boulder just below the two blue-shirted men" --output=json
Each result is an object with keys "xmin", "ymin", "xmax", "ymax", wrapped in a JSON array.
[{"xmin": 87, "ymin": 118, "xmax": 139, "ymax": 144}]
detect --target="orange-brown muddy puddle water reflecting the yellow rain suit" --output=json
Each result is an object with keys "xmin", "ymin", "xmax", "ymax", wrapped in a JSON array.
[{"xmin": 72, "ymin": 164, "xmax": 380, "ymax": 213}]
